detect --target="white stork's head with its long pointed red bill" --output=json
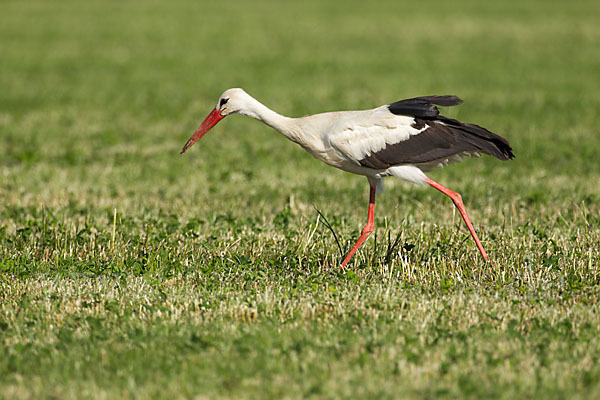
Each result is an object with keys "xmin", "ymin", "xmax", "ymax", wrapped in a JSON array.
[{"xmin": 181, "ymin": 88, "xmax": 255, "ymax": 154}]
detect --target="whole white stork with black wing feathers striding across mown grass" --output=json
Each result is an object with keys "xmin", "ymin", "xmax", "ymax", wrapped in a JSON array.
[{"xmin": 180, "ymin": 88, "xmax": 514, "ymax": 269}]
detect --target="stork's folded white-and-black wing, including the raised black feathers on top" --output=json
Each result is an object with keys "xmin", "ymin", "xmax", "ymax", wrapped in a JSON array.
[{"xmin": 330, "ymin": 101, "xmax": 513, "ymax": 169}]
